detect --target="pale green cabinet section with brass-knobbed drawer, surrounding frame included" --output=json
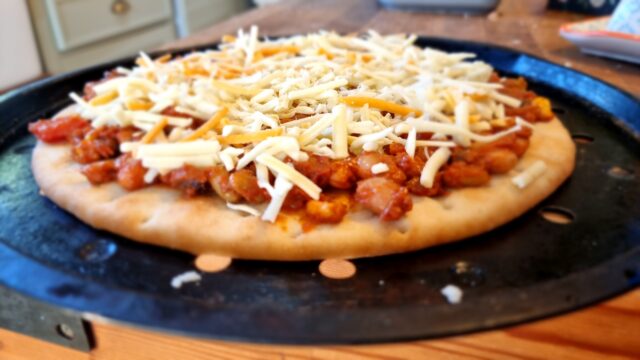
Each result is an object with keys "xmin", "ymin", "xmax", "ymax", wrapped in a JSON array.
[{"xmin": 29, "ymin": 0, "xmax": 175, "ymax": 73}]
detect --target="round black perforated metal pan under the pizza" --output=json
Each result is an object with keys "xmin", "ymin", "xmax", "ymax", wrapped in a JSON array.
[{"xmin": 0, "ymin": 38, "xmax": 640, "ymax": 344}]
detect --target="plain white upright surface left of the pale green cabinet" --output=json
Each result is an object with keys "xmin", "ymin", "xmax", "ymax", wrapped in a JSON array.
[{"xmin": 0, "ymin": 0, "xmax": 42, "ymax": 90}]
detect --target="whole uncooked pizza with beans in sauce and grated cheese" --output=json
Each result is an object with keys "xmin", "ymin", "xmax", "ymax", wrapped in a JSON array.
[{"xmin": 29, "ymin": 27, "xmax": 575, "ymax": 260}]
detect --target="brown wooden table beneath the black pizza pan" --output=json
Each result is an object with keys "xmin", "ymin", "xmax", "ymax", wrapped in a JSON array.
[{"xmin": 0, "ymin": 0, "xmax": 640, "ymax": 360}]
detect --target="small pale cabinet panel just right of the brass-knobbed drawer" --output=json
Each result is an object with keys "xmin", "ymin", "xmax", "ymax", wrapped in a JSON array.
[{"xmin": 174, "ymin": 0, "xmax": 250, "ymax": 37}]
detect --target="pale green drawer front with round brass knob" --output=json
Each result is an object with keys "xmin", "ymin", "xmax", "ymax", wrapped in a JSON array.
[{"xmin": 45, "ymin": 0, "xmax": 171, "ymax": 51}]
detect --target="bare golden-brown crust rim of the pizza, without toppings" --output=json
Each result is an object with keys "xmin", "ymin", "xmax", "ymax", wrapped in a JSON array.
[{"xmin": 32, "ymin": 110, "xmax": 575, "ymax": 260}]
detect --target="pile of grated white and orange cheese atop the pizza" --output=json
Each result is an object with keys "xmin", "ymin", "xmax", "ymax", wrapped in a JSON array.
[{"xmin": 70, "ymin": 27, "xmax": 530, "ymax": 221}]
